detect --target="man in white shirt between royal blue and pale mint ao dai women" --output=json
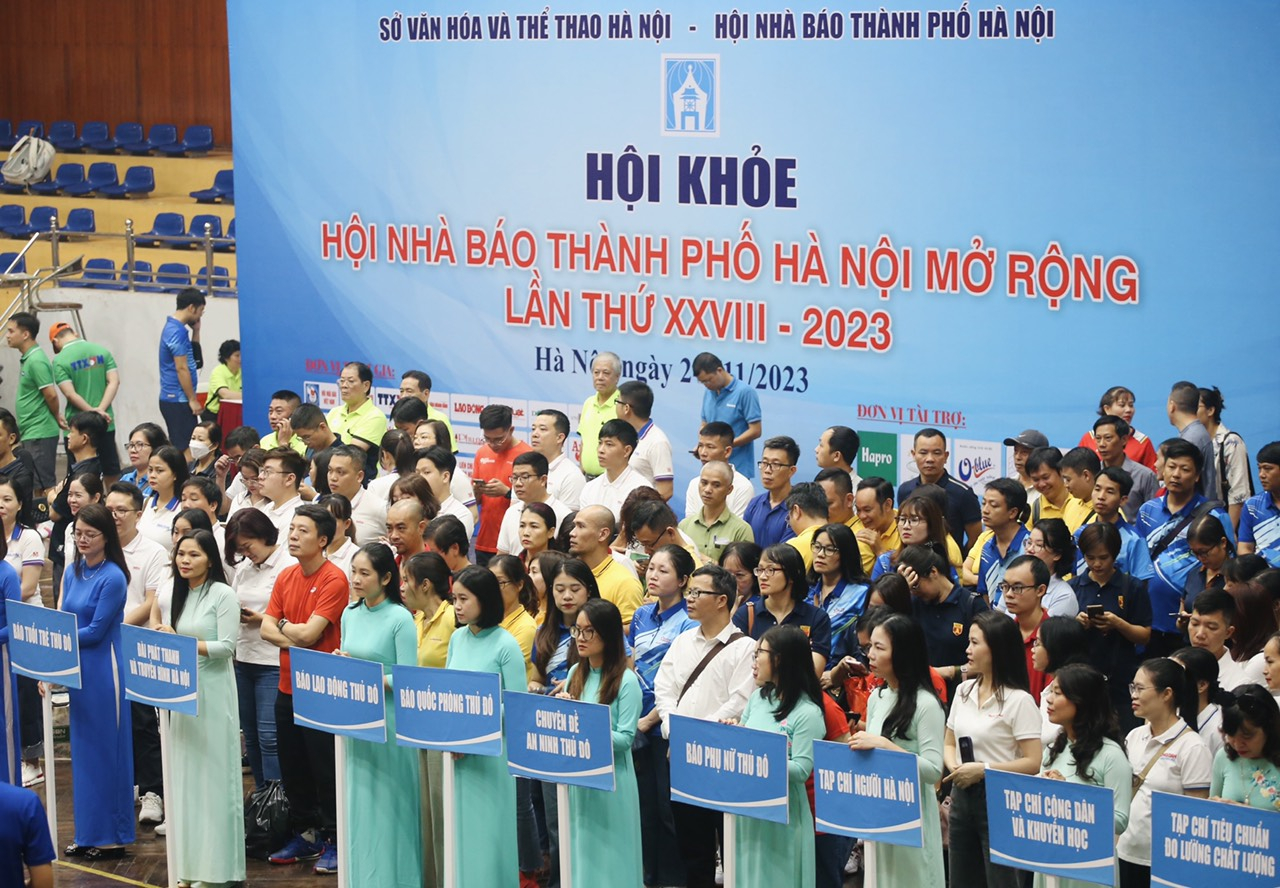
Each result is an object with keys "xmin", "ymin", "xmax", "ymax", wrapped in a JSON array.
[{"xmin": 106, "ymin": 481, "xmax": 169, "ymax": 823}]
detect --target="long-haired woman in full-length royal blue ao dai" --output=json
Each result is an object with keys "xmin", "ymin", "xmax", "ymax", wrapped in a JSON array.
[{"xmin": 60, "ymin": 503, "xmax": 133, "ymax": 860}]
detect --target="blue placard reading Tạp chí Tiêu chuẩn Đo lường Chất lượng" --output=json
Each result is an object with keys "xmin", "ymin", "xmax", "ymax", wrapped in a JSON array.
[{"xmin": 1151, "ymin": 792, "xmax": 1280, "ymax": 888}]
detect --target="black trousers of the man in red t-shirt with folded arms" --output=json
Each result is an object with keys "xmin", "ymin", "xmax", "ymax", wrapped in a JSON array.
[{"xmin": 275, "ymin": 692, "xmax": 338, "ymax": 836}]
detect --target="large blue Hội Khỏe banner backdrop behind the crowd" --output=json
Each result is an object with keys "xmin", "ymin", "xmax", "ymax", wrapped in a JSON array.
[{"xmin": 225, "ymin": 0, "xmax": 1280, "ymax": 490}]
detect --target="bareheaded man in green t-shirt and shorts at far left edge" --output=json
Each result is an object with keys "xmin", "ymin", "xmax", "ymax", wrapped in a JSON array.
[{"xmin": 5, "ymin": 311, "xmax": 67, "ymax": 496}]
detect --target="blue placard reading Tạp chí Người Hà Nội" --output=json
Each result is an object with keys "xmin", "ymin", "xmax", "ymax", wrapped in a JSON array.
[{"xmin": 813, "ymin": 741, "xmax": 923, "ymax": 848}]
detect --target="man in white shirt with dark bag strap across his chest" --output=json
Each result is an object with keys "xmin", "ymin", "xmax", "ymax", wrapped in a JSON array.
[{"xmin": 654, "ymin": 564, "xmax": 755, "ymax": 885}]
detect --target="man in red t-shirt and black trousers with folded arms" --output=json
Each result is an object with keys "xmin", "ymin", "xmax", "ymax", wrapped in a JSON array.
[{"xmin": 261, "ymin": 504, "xmax": 349, "ymax": 873}]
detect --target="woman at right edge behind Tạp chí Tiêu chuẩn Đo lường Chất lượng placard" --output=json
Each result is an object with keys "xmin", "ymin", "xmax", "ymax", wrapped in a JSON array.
[{"xmin": 1210, "ymin": 685, "xmax": 1280, "ymax": 811}]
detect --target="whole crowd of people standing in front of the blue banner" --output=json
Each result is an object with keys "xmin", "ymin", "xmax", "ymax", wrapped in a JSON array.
[{"xmin": 0, "ymin": 290, "xmax": 1280, "ymax": 888}]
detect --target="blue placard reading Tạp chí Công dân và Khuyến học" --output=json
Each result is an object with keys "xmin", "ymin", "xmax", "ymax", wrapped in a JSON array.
[{"xmin": 987, "ymin": 769, "xmax": 1116, "ymax": 885}]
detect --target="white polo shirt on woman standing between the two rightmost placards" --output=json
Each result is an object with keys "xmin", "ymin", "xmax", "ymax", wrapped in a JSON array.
[{"xmin": 1116, "ymin": 719, "xmax": 1213, "ymax": 866}]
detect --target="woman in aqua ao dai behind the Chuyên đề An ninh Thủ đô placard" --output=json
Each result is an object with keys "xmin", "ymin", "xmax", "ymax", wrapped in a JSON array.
[{"xmin": 561, "ymin": 599, "xmax": 644, "ymax": 888}]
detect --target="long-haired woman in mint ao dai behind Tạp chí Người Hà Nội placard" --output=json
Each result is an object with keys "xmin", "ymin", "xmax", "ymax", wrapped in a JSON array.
[{"xmin": 849, "ymin": 614, "xmax": 946, "ymax": 888}]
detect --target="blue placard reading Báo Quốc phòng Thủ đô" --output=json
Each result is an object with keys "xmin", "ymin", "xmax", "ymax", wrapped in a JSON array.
[{"xmin": 392, "ymin": 665, "xmax": 502, "ymax": 755}]
